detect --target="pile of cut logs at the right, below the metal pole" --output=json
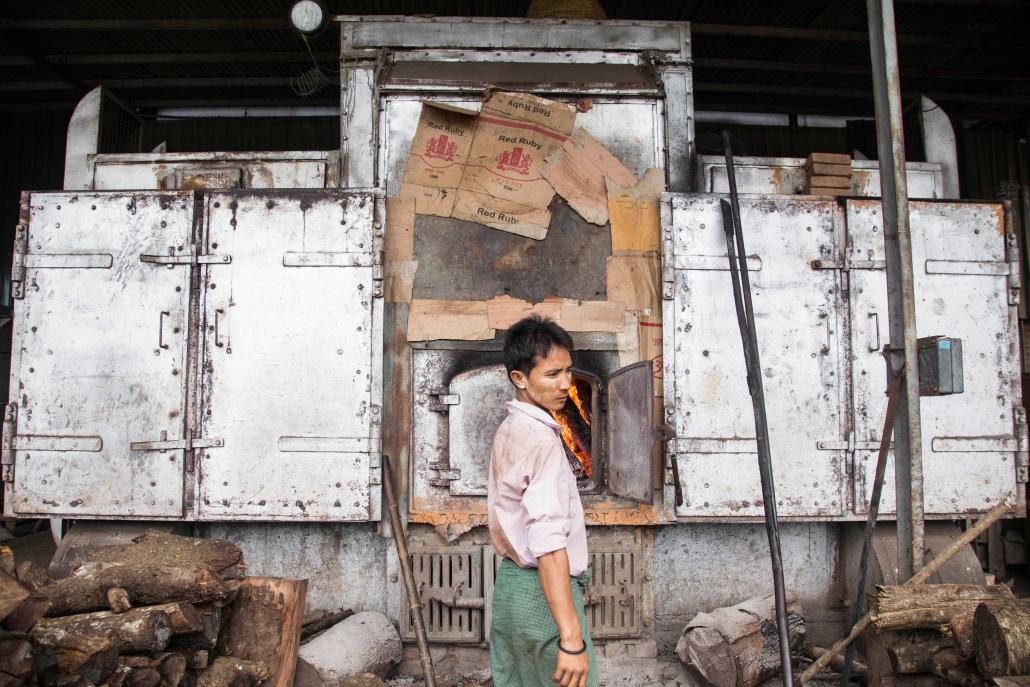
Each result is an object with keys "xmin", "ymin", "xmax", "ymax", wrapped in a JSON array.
[{"xmin": 873, "ymin": 584, "xmax": 1030, "ymax": 687}]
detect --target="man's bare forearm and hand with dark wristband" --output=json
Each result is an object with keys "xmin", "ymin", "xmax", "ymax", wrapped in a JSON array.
[{"xmin": 537, "ymin": 549, "xmax": 590, "ymax": 687}]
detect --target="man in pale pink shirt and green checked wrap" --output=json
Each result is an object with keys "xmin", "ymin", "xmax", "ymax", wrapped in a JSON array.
[{"xmin": 487, "ymin": 316, "xmax": 598, "ymax": 687}]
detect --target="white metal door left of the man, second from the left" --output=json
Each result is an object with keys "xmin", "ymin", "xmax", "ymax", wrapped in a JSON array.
[{"xmin": 198, "ymin": 192, "xmax": 382, "ymax": 520}]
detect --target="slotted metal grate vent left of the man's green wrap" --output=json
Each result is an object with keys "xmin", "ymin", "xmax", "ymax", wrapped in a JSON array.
[{"xmin": 401, "ymin": 546, "xmax": 485, "ymax": 644}]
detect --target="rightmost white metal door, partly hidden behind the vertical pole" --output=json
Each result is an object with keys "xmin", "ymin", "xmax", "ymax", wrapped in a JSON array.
[{"xmin": 847, "ymin": 201, "xmax": 1020, "ymax": 515}]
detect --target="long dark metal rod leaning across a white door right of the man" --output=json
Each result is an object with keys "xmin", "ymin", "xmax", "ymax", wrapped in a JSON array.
[{"xmin": 720, "ymin": 132, "xmax": 794, "ymax": 685}]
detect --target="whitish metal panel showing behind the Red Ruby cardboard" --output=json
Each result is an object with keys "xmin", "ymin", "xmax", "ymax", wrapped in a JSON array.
[{"xmin": 380, "ymin": 94, "xmax": 664, "ymax": 196}]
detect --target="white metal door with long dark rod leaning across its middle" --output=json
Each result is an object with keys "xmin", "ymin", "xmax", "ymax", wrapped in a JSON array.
[{"xmin": 662, "ymin": 195, "xmax": 849, "ymax": 518}]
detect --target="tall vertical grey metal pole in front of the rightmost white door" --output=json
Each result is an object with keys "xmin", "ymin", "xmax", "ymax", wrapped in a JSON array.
[{"xmin": 866, "ymin": 0, "xmax": 924, "ymax": 582}]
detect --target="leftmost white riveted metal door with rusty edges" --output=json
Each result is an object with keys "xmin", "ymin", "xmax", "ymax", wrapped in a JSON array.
[{"xmin": 5, "ymin": 193, "xmax": 193, "ymax": 517}]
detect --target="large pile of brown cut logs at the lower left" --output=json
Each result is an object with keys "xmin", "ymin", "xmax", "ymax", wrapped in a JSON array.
[{"xmin": 0, "ymin": 530, "xmax": 325, "ymax": 687}]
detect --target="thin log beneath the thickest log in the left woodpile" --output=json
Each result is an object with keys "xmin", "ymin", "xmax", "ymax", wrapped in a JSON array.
[{"xmin": 30, "ymin": 607, "xmax": 172, "ymax": 653}]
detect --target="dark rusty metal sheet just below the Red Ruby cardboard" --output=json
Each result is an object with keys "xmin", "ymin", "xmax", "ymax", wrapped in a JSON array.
[{"xmin": 413, "ymin": 200, "xmax": 612, "ymax": 303}]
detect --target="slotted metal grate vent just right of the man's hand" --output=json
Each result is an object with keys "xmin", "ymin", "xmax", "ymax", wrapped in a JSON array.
[{"xmin": 586, "ymin": 547, "xmax": 644, "ymax": 639}]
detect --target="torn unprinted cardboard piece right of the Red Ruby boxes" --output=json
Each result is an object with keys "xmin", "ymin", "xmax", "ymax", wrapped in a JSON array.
[{"xmin": 541, "ymin": 128, "xmax": 637, "ymax": 225}]
